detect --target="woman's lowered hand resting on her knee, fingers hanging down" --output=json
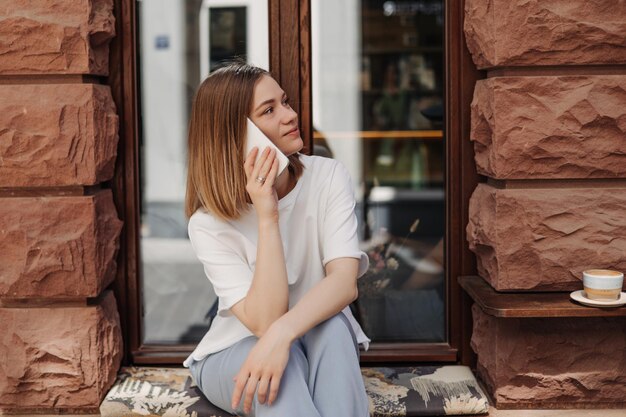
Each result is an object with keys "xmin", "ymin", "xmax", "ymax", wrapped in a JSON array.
[{"xmin": 231, "ymin": 322, "xmax": 293, "ymax": 414}]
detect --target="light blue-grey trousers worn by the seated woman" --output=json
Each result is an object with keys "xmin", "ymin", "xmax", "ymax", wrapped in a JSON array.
[{"xmin": 189, "ymin": 312, "xmax": 369, "ymax": 417}]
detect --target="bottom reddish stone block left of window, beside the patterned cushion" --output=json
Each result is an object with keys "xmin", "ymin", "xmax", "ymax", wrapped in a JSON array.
[{"xmin": 0, "ymin": 291, "xmax": 122, "ymax": 411}]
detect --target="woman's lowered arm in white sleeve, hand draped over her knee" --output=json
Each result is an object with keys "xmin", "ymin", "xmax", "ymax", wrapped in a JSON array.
[{"xmin": 232, "ymin": 159, "xmax": 367, "ymax": 411}]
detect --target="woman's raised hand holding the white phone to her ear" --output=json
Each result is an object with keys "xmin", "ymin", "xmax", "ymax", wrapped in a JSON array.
[{"xmin": 244, "ymin": 146, "xmax": 278, "ymax": 220}]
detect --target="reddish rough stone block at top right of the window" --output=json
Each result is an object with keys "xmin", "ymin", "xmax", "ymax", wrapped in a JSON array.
[{"xmin": 464, "ymin": 0, "xmax": 626, "ymax": 68}]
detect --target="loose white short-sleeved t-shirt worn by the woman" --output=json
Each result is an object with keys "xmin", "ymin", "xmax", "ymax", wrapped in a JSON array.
[{"xmin": 183, "ymin": 154, "xmax": 370, "ymax": 367}]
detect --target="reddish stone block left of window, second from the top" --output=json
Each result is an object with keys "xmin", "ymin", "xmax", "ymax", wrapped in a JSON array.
[{"xmin": 0, "ymin": 84, "xmax": 118, "ymax": 187}]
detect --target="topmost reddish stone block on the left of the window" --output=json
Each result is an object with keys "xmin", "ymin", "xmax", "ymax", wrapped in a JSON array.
[{"xmin": 0, "ymin": 0, "xmax": 115, "ymax": 75}]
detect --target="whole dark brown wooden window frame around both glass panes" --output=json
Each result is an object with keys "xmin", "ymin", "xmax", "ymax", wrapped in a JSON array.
[{"xmin": 107, "ymin": 0, "xmax": 482, "ymax": 366}]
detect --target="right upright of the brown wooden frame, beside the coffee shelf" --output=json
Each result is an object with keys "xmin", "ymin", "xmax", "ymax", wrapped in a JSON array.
[{"xmin": 444, "ymin": 0, "xmax": 484, "ymax": 368}]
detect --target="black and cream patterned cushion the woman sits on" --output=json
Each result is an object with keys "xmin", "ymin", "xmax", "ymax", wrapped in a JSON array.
[{"xmin": 100, "ymin": 366, "xmax": 489, "ymax": 417}]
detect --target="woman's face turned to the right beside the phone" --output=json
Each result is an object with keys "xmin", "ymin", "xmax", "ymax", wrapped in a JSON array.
[{"xmin": 250, "ymin": 75, "xmax": 304, "ymax": 156}]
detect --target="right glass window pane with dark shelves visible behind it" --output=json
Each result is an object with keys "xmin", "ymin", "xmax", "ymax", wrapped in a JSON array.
[{"xmin": 311, "ymin": 0, "xmax": 446, "ymax": 342}]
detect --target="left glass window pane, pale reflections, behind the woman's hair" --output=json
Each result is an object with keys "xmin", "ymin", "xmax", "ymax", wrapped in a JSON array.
[{"xmin": 137, "ymin": 0, "xmax": 269, "ymax": 344}]
